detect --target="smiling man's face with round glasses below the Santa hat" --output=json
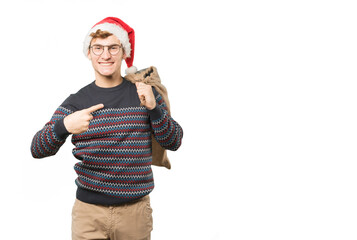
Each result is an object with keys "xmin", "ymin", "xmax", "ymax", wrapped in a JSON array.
[{"xmin": 88, "ymin": 35, "xmax": 125, "ymax": 77}]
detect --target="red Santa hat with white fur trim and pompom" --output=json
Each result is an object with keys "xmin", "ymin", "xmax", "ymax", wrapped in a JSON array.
[{"xmin": 83, "ymin": 17, "xmax": 137, "ymax": 74}]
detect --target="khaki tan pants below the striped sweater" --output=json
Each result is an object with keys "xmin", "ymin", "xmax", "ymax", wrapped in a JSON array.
[{"xmin": 72, "ymin": 196, "xmax": 153, "ymax": 240}]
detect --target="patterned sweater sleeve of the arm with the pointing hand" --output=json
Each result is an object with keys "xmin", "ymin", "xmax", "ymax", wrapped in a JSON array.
[{"xmin": 31, "ymin": 96, "xmax": 74, "ymax": 158}]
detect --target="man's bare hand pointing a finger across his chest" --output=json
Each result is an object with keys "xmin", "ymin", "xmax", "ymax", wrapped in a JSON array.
[{"xmin": 63, "ymin": 104, "xmax": 104, "ymax": 134}]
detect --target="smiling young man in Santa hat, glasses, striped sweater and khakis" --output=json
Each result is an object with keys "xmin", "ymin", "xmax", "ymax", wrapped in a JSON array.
[{"xmin": 31, "ymin": 17, "xmax": 183, "ymax": 240}]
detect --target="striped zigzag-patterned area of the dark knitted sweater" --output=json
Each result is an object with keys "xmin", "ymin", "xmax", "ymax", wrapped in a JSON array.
[{"xmin": 31, "ymin": 87, "xmax": 183, "ymax": 201}]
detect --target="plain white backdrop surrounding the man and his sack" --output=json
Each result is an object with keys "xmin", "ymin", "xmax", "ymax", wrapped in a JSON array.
[{"xmin": 0, "ymin": 0, "xmax": 357, "ymax": 240}]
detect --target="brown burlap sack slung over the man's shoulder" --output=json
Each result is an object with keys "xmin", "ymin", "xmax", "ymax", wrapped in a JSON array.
[{"xmin": 124, "ymin": 66, "xmax": 171, "ymax": 169}]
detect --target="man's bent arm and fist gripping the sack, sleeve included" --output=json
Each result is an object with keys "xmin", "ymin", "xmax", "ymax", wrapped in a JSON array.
[{"xmin": 136, "ymin": 83, "xmax": 183, "ymax": 151}]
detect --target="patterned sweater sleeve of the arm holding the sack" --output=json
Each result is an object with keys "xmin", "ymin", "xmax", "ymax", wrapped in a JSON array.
[{"xmin": 149, "ymin": 91, "xmax": 183, "ymax": 151}]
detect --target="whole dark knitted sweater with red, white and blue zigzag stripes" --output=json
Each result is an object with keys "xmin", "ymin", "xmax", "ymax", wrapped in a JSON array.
[{"xmin": 31, "ymin": 79, "xmax": 183, "ymax": 205}]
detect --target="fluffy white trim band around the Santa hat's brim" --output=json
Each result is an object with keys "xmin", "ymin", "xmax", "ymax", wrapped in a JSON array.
[{"xmin": 83, "ymin": 23, "xmax": 131, "ymax": 57}]
